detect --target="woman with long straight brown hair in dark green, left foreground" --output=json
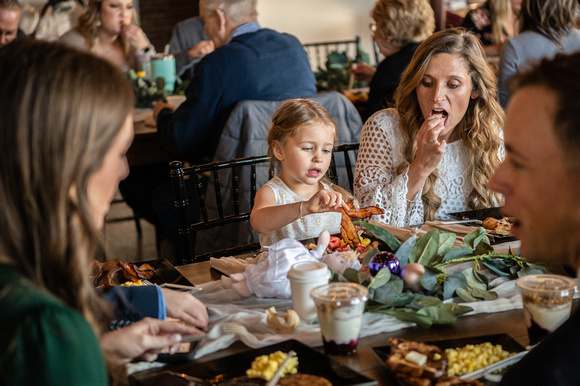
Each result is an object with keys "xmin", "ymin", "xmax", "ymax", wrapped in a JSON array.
[{"xmin": 0, "ymin": 39, "xmax": 199, "ymax": 385}]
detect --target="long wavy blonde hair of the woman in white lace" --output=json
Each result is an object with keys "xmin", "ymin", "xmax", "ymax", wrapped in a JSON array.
[{"xmin": 394, "ymin": 28, "xmax": 504, "ymax": 220}]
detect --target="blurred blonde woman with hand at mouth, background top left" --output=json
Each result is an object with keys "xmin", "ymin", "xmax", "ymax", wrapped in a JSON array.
[{"xmin": 60, "ymin": 0, "xmax": 155, "ymax": 71}]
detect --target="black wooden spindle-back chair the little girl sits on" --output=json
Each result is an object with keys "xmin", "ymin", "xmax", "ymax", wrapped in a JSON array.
[{"xmin": 170, "ymin": 143, "xmax": 359, "ymax": 264}]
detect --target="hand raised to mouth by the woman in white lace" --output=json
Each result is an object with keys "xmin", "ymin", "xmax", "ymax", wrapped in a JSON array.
[{"xmin": 413, "ymin": 114, "xmax": 447, "ymax": 178}]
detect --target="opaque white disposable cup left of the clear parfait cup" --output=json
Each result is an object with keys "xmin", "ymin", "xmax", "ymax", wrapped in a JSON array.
[{"xmin": 288, "ymin": 261, "xmax": 330, "ymax": 323}]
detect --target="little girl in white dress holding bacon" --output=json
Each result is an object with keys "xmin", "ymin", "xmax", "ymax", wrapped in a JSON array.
[{"xmin": 250, "ymin": 99, "xmax": 346, "ymax": 248}]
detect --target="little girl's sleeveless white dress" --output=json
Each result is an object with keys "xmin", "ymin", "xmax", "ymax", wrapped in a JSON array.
[{"xmin": 260, "ymin": 176, "xmax": 342, "ymax": 249}]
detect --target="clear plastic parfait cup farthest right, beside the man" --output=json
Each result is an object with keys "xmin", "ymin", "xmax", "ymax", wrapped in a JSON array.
[{"xmin": 516, "ymin": 274, "xmax": 576, "ymax": 345}]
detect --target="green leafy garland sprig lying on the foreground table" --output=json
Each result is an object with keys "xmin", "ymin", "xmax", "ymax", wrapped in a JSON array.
[{"xmin": 333, "ymin": 221, "xmax": 545, "ymax": 327}]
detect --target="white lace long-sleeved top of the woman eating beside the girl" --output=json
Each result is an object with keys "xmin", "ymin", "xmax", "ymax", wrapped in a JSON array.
[{"xmin": 354, "ymin": 109, "xmax": 482, "ymax": 227}]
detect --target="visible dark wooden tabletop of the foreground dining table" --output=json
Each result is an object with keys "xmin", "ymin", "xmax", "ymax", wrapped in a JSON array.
[{"xmin": 142, "ymin": 262, "xmax": 529, "ymax": 385}]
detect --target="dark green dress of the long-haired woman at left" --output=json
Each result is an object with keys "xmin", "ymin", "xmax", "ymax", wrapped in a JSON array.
[{"xmin": 0, "ymin": 264, "xmax": 108, "ymax": 385}]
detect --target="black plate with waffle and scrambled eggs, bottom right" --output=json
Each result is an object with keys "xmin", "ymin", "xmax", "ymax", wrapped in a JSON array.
[{"xmin": 373, "ymin": 334, "xmax": 527, "ymax": 385}]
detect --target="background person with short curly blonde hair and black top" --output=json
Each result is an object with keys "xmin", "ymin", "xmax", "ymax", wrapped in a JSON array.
[{"xmin": 351, "ymin": 0, "xmax": 435, "ymax": 120}]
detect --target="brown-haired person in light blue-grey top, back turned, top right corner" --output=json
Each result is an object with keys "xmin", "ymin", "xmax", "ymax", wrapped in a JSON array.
[{"xmin": 499, "ymin": 0, "xmax": 580, "ymax": 108}]
